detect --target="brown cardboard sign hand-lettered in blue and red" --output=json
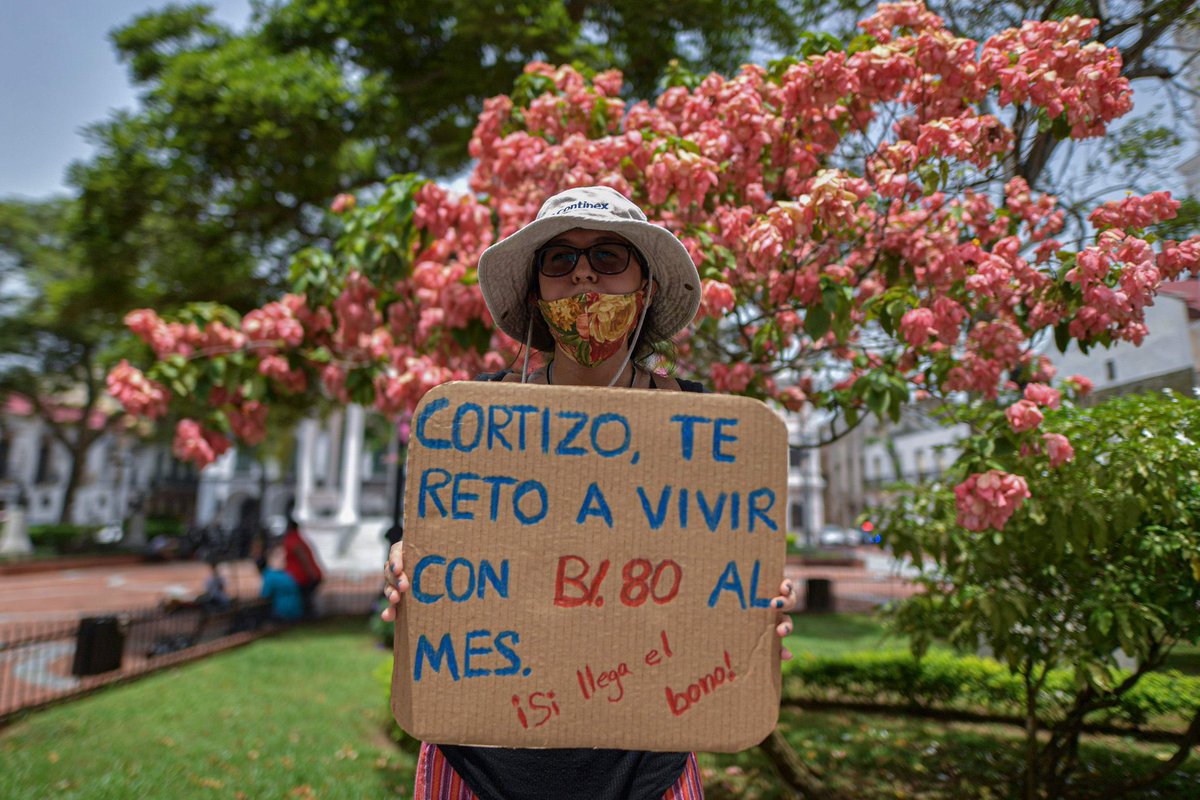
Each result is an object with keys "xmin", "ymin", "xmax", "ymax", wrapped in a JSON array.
[{"xmin": 392, "ymin": 383, "xmax": 787, "ymax": 752}]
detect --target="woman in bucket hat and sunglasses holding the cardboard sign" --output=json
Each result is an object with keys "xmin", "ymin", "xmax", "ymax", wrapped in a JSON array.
[{"xmin": 383, "ymin": 186, "xmax": 796, "ymax": 800}]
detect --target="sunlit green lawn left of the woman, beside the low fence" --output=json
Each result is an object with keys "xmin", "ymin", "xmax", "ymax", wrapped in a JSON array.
[{"xmin": 0, "ymin": 622, "xmax": 414, "ymax": 800}]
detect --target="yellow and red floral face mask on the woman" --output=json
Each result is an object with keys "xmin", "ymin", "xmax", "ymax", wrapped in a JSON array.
[{"xmin": 538, "ymin": 290, "xmax": 646, "ymax": 367}]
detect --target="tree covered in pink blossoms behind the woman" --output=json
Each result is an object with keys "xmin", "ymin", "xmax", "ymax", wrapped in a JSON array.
[{"xmin": 109, "ymin": 2, "xmax": 1200, "ymax": 530}]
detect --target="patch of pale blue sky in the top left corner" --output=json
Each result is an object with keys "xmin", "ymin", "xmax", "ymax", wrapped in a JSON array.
[{"xmin": 0, "ymin": 0, "xmax": 250, "ymax": 199}]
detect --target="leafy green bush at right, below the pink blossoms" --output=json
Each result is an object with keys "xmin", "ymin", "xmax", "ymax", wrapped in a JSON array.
[{"xmin": 876, "ymin": 391, "xmax": 1200, "ymax": 799}]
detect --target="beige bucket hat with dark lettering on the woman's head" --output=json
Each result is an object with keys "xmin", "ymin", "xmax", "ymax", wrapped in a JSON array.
[{"xmin": 479, "ymin": 186, "xmax": 700, "ymax": 351}]
